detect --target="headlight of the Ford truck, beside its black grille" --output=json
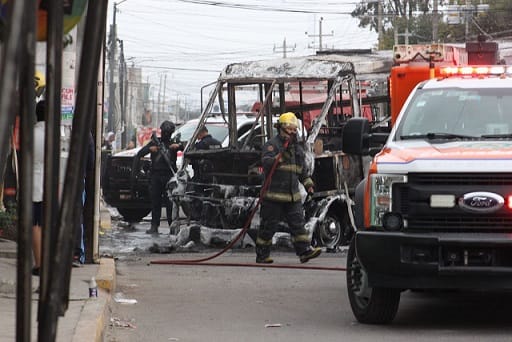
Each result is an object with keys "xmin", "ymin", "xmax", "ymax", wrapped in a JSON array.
[{"xmin": 370, "ymin": 173, "xmax": 407, "ymax": 226}]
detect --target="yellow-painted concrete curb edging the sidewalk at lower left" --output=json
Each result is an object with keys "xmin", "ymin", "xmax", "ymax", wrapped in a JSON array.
[{"xmin": 71, "ymin": 258, "xmax": 116, "ymax": 342}]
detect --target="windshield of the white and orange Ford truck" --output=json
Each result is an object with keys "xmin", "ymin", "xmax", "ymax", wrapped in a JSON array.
[{"xmin": 395, "ymin": 88, "xmax": 512, "ymax": 139}]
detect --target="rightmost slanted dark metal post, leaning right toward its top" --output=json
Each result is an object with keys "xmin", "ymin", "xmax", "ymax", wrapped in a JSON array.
[{"xmin": 42, "ymin": 0, "xmax": 108, "ymax": 341}]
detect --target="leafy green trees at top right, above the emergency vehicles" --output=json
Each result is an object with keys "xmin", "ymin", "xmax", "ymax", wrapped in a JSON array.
[{"xmin": 352, "ymin": 0, "xmax": 512, "ymax": 49}]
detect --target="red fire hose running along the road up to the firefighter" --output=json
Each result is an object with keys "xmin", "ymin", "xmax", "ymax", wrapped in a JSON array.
[{"xmin": 150, "ymin": 140, "xmax": 346, "ymax": 271}]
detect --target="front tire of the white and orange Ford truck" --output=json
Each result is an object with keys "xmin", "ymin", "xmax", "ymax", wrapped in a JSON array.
[{"xmin": 347, "ymin": 237, "xmax": 401, "ymax": 324}]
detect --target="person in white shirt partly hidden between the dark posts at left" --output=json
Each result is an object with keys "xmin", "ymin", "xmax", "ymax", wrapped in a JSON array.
[{"xmin": 32, "ymin": 100, "xmax": 46, "ymax": 276}]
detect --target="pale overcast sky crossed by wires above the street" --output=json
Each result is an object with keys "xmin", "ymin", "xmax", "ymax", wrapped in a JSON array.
[{"xmin": 107, "ymin": 0, "xmax": 377, "ymax": 108}]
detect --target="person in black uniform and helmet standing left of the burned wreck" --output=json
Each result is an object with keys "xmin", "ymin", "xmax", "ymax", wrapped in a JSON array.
[{"xmin": 132, "ymin": 121, "xmax": 184, "ymax": 234}]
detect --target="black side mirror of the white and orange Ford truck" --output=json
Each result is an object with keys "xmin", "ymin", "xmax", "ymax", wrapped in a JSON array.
[{"xmin": 342, "ymin": 118, "xmax": 370, "ymax": 155}]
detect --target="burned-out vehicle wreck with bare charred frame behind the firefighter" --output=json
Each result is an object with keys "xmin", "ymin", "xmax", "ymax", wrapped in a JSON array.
[{"xmin": 169, "ymin": 56, "xmax": 388, "ymax": 248}]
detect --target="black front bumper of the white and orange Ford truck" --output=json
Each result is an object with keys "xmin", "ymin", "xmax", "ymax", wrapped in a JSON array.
[{"xmin": 355, "ymin": 231, "xmax": 512, "ymax": 289}]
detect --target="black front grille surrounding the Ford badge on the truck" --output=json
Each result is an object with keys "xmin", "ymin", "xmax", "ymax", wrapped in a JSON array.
[{"xmin": 393, "ymin": 173, "xmax": 512, "ymax": 233}]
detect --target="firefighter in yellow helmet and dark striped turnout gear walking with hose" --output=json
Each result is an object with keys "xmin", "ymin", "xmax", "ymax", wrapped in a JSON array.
[{"xmin": 256, "ymin": 112, "xmax": 321, "ymax": 264}]
